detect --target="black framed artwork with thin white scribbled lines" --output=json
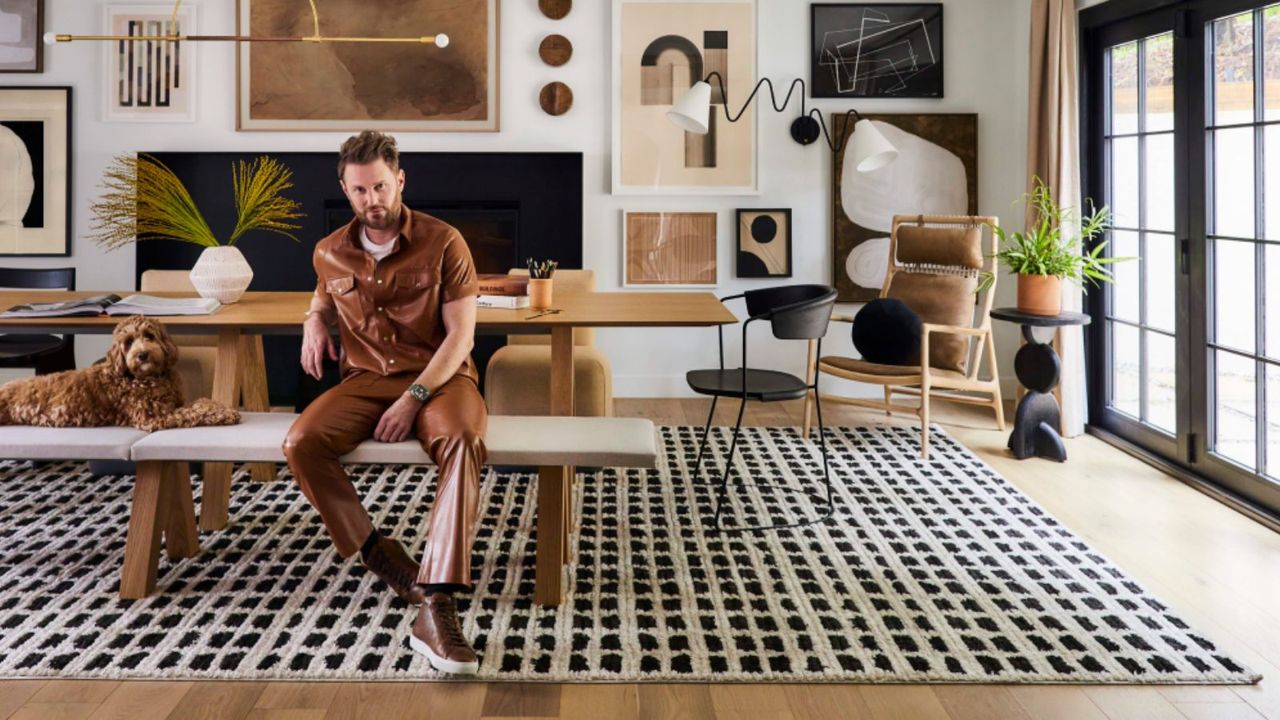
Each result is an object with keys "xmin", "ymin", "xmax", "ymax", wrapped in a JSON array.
[{"xmin": 809, "ymin": 3, "xmax": 942, "ymax": 97}]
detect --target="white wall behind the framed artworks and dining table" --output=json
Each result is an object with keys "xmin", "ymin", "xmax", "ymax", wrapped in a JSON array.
[{"xmin": 0, "ymin": 0, "xmax": 1030, "ymax": 397}]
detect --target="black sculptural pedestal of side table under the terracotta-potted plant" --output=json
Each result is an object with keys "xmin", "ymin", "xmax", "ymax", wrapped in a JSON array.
[{"xmin": 1009, "ymin": 325, "xmax": 1066, "ymax": 462}]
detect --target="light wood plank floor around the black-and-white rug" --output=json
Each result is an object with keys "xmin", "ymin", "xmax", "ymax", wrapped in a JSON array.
[{"xmin": 0, "ymin": 400, "xmax": 1280, "ymax": 720}]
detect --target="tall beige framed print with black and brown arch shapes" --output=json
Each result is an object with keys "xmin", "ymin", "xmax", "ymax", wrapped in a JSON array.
[{"xmin": 613, "ymin": 0, "xmax": 759, "ymax": 195}]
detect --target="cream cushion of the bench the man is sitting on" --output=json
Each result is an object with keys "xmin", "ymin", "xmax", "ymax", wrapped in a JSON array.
[{"xmin": 132, "ymin": 413, "xmax": 658, "ymax": 468}]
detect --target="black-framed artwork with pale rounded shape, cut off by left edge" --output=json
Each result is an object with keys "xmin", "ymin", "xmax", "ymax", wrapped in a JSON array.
[{"xmin": 0, "ymin": 86, "xmax": 72, "ymax": 256}]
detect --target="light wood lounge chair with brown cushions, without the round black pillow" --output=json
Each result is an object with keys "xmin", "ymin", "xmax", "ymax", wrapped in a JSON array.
[{"xmin": 804, "ymin": 215, "xmax": 1005, "ymax": 457}]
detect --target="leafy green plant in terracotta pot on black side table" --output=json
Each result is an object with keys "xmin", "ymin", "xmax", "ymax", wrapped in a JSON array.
[{"xmin": 979, "ymin": 177, "xmax": 1132, "ymax": 315}]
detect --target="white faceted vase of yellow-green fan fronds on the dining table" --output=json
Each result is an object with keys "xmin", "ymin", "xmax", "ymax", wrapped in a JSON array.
[{"xmin": 90, "ymin": 154, "xmax": 302, "ymax": 302}]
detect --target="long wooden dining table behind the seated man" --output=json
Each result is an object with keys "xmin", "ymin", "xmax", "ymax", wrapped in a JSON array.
[{"xmin": 0, "ymin": 290, "xmax": 737, "ymax": 530}]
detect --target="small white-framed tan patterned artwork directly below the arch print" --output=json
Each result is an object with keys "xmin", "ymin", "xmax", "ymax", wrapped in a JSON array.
[{"xmin": 622, "ymin": 211, "xmax": 719, "ymax": 288}]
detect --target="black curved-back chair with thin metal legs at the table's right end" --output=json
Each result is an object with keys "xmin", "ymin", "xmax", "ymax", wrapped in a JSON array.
[{"xmin": 685, "ymin": 284, "xmax": 836, "ymax": 532}]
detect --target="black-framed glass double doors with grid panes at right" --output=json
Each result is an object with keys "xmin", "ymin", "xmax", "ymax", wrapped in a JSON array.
[{"xmin": 1084, "ymin": 0, "xmax": 1280, "ymax": 512}]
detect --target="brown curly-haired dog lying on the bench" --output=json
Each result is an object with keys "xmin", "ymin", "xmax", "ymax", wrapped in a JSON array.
[{"xmin": 0, "ymin": 316, "xmax": 239, "ymax": 432}]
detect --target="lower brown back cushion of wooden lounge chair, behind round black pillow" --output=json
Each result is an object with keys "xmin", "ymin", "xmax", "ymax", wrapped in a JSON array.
[{"xmin": 886, "ymin": 269, "xmax": 978, "ymax": 373}]
